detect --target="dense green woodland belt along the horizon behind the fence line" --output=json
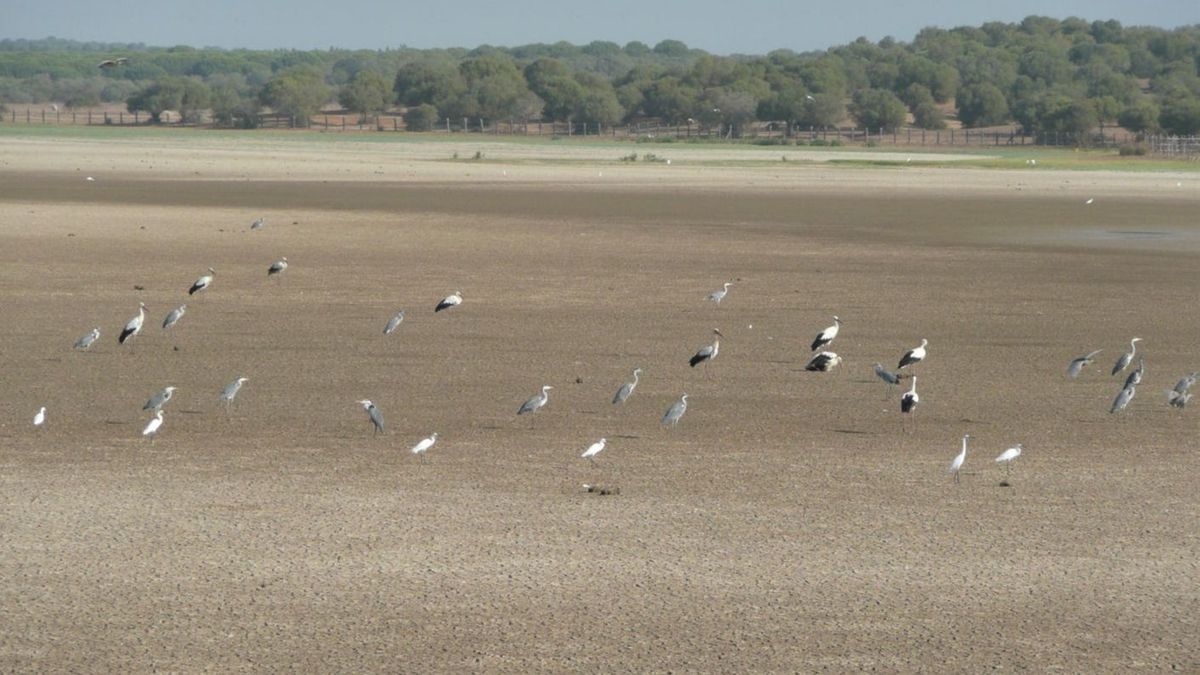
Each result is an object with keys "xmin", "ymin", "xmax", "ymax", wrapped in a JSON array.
[{"xmin": 0, "ymin": 17, "xmax": 1200, "ymax": 135}]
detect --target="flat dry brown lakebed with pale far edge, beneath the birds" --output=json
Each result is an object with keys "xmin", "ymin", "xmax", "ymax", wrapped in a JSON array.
[{"xmin": 0, "ymin": 133, "xmax": 1200, "ymax": 671}]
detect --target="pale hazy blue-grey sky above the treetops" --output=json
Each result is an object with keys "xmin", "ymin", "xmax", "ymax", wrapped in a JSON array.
[{"xmin": 0, "ymin": 0, "xmax": 1200, "ymax": 54}]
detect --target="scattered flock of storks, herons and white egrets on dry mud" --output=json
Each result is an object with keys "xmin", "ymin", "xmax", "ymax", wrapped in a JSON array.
[{"xmin": 23, "ymin": 219, "xmax": 1200, "ymax": 482}]
